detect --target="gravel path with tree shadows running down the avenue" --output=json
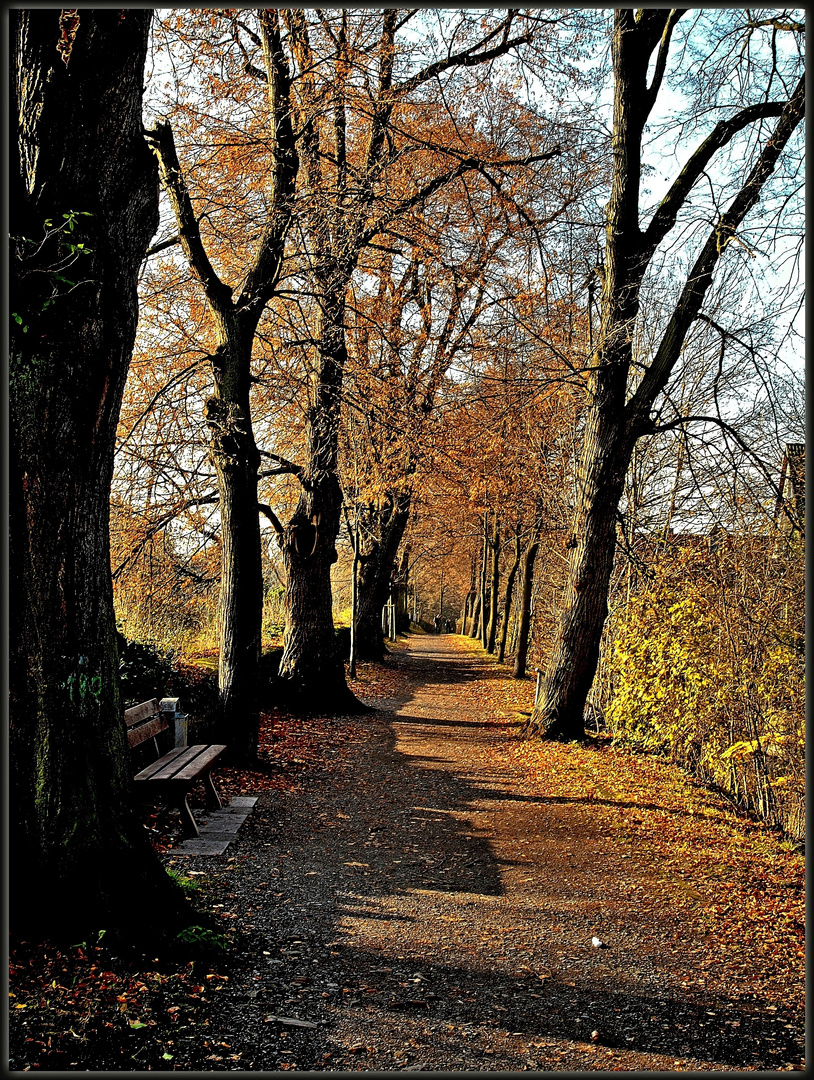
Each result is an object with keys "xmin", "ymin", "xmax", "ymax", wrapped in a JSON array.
[{"xmin": 174, "ymin": 636, "xmax": 802, "ymax": 1071}]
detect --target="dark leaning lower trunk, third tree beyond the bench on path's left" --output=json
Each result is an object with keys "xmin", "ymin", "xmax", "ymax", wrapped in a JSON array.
[{"xmin": 358, "ymin": 491, "xmax": 411, "ymax": 660}]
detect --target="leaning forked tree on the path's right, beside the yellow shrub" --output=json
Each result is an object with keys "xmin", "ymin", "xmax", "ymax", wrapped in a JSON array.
[{"xmin": 529, "ymin": 10, "xmax": 804, "ymax": 740}]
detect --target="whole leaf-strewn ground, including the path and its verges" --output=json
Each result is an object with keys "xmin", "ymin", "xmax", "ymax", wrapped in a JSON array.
[{"xmin": 10, "ymin": 635, "xmax": 804, "ymax": 1071}]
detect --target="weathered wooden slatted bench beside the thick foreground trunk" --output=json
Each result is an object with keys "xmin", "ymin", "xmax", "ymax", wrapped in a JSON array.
[{"xmin": 124, "ymin": 698, "xmax": 226, "ymax": 836}]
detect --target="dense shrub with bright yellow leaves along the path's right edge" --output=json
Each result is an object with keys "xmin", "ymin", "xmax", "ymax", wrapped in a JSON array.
[{"xmin": 607, "ymin": 535, "xmax": 805, "ymax": 838}]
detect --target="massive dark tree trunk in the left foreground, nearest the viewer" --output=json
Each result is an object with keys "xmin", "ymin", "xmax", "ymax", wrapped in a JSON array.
[{"xmin": 9, "ymin": 9, "xmax": 182, "ymax": 935}]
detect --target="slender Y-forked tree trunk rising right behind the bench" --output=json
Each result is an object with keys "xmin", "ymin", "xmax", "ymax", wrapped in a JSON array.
[{"xmin": 147, "ymin": 10, "xmax": 299, "ymax": 760}]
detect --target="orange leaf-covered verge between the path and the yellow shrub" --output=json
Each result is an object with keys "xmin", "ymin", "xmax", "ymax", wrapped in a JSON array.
[{"xmin": 457, "ymin": 630, "xmax": 805, "ymax": 1012}]
